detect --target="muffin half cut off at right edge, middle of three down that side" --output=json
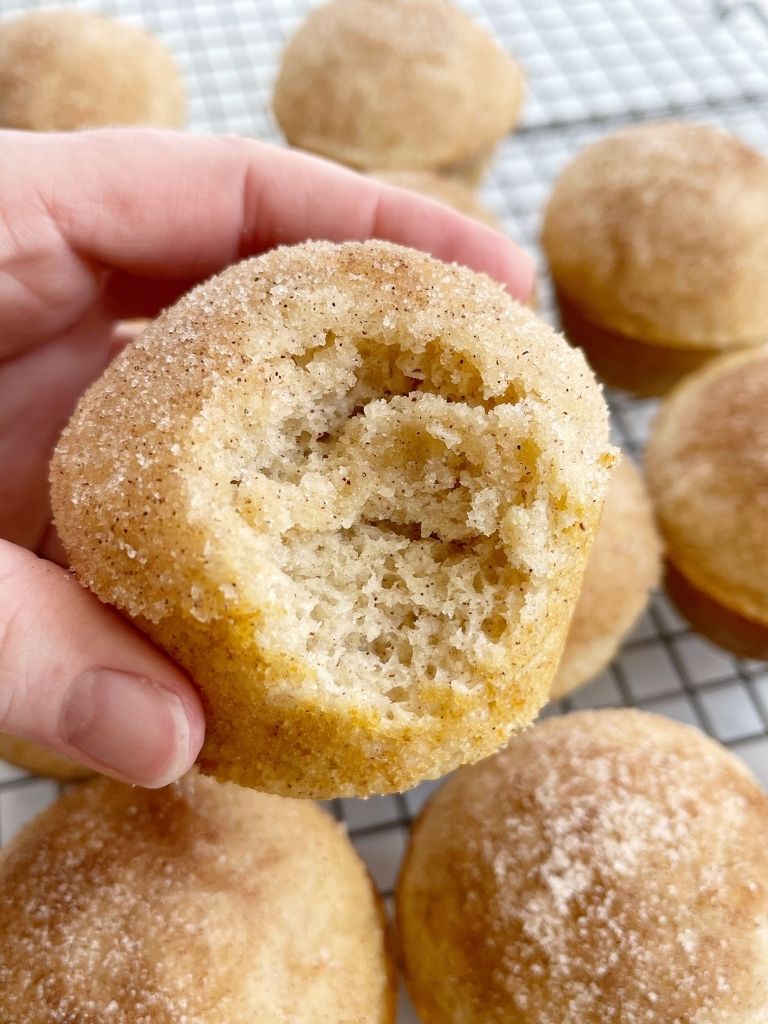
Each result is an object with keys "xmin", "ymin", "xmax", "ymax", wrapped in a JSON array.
[{"xmin": 646, "ymin": 346, "xmax": 768, "ymax": 658}]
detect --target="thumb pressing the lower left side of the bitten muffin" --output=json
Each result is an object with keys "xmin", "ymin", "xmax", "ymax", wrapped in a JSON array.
[{"xmin": 0, "ymin": 541, "xmax": 205, "ymax": 787}]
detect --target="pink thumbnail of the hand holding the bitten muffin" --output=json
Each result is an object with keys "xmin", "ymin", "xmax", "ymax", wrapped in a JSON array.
[{"xmin": 60, "ymin": 669, "xmax": 189, "ymax": 786}]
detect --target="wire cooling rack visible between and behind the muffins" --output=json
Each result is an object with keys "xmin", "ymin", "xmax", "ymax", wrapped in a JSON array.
[{"xmin": 0, "ymin": 0, "xmax": 768, "ymax": 1024}]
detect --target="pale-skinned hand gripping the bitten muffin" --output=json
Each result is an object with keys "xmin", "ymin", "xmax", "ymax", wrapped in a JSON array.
[{"xmin": 0, "ymin": 130, "xmax": 532, "ymax": 786}]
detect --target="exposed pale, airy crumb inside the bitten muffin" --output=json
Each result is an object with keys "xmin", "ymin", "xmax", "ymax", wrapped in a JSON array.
[{"xmin": 193, "ymin": 331, "xmax": 546, "ymax": 714}]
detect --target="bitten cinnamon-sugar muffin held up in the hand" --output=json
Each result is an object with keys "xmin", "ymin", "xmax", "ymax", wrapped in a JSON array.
[{"xmin": 51, "ymin": 242, "xmax": 613, "ymax": 798}]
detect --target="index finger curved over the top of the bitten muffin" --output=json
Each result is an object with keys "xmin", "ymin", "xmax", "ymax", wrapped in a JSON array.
[{"xmin": 41, "ymin": 129, "xmax": 532, "ymax": 299}]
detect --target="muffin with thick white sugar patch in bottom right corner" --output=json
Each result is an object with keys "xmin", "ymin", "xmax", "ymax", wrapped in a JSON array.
[{"xmin": 397, "ymin": 709, "xmax": 768, "ymax": 1024}]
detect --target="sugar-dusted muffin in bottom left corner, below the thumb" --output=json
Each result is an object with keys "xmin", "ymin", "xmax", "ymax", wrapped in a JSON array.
[{"xmin": 0, "ymin": 774, "xmax": 394, "ymax": 1024}]
